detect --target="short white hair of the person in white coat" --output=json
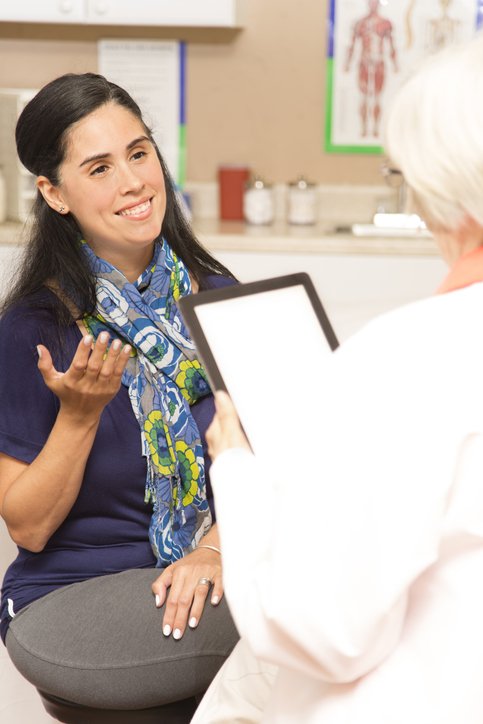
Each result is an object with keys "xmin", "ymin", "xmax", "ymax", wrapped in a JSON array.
[{"xmin": 385, "ymin": 34, "xmax": 483, "ymax": 231}]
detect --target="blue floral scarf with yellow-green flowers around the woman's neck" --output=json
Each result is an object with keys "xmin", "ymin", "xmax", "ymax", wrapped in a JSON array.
[{"xmin": 82, "ymin": 241, "xmax": 211, "ymax": 568}]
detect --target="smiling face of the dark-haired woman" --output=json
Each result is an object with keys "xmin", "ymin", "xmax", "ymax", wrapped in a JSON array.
[{"xmin": 58, "ymin": 103, "xmax": 166, "ymax": 268}]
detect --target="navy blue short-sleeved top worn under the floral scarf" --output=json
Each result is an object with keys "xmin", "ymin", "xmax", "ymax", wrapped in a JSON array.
[{"xmin": 0, "ymin": 276, "xmax": 233, "ymax": 641}]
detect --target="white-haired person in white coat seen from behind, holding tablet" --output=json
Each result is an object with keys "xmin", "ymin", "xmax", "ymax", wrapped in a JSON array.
[{"xmin": 193, "ymin": 36, "xmax": 483, "ymax": 724}]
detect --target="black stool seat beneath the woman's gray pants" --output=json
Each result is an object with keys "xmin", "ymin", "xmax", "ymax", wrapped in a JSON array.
[{"xmin": 37, "ymin": 689, "xmax": 198, "ymax": 724}]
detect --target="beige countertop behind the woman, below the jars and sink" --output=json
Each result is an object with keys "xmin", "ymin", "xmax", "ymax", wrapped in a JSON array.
[{"xmin": 0, "ymin": 220, "xmax": 439, "ymax": 256}]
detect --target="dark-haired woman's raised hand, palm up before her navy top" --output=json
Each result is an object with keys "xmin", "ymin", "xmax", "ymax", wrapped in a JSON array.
[{"xmin": 37, "ymin": 332, "xmax": 131, "ymax": 421}]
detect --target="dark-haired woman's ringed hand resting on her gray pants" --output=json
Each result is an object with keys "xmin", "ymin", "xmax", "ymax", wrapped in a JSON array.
[{"xmin": 152, "ymin": 544, "xmax": 223, "ymax": 639}]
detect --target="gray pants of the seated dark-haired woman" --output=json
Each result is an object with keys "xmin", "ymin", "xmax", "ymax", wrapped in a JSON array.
[{"xmin": 7, "ymin": 569, "xmax": 238, "ymax": 709}]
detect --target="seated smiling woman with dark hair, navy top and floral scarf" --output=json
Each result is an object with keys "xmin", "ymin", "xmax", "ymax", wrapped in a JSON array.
[{"xmin": 0, "ymin": 73, "xmax": 237, "ymax": 722}]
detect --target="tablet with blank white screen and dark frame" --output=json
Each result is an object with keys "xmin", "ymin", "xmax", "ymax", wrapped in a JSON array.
[{"xmin": 178, "ymin": 273, "xmax": 338, "ymax": 455}]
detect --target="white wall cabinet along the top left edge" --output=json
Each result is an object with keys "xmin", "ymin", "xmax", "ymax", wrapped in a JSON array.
[{"xmin": 0, "ymin": 0, "xmax": 241, "ymax": 28}]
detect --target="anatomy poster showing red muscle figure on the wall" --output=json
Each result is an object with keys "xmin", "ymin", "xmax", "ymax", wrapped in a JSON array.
[{"xmin": 325, "ymin": 0, "xmax": 483, "ymax": 153}]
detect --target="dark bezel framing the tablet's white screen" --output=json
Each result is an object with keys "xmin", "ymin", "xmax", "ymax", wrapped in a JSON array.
[{"xmin": 177, "ymin": 272, "xmax": 339, "ymax": 392}]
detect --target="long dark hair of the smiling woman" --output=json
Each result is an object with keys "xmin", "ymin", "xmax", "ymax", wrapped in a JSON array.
[{"xmin": 3, "ymin": 73, "xmax": 233, "ymax": 326}]
